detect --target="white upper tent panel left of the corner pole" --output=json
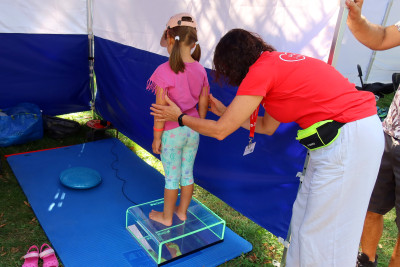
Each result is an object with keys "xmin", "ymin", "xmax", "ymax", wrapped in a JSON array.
[{"xmin": 0, "ymin": 0, "xmax": 87, "ymax": 34}]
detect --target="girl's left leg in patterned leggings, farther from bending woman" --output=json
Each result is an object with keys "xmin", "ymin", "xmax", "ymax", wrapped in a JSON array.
[{"xmin": 149, "ymin": 128, "xmax": 183, "ymax": 226}]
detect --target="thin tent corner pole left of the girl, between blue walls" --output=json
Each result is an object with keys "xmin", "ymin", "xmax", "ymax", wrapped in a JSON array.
[{"xmin": 86, "ymin": 0, "xmax": 96, "ymax": 117}]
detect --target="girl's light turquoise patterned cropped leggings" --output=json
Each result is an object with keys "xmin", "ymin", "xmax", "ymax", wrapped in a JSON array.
[{"xmin": 161, "ymin": 126, "xmax": 200, "ymax": 189}]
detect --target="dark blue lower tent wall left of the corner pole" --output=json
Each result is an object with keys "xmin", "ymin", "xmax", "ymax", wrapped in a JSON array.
[{"xmin": 0, "ymin": 33, "xmax": 91, "ymax": 115}]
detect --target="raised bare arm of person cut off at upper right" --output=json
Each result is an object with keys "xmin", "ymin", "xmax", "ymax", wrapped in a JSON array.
[{"xmin": 346, "ymin": 0, "xmax": 400, "ymax": 50}]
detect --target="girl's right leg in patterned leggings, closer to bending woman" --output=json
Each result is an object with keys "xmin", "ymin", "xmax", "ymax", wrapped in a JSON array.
[{"xmin": 176, "ymin": 127, "xmax": 200, "ymax": 221}]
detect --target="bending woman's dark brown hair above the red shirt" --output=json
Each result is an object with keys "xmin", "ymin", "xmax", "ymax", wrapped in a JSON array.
[{"xmin": 213, "ymin": 29, "xmax": 276, "ymax": 86}]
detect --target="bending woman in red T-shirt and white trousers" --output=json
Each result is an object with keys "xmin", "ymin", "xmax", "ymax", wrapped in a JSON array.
[{"xmin": 151, "ymin": 29, "xmax": 384, "ymax": 267}]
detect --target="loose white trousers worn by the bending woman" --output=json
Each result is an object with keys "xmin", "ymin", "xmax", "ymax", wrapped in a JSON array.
[{"xmin": 286, "ymin": 115, "xmax": 384, "ymax": 267}]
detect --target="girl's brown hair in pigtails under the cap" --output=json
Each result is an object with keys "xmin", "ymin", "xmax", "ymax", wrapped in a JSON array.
[{"xmin": 168, "ymin": 26, "xmax": 201, "ymax": 73}]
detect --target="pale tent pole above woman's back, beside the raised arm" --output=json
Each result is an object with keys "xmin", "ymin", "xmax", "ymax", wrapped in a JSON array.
[{"xmin": 328, "ymin": 1, "xmax": 349, "ymax": 67}]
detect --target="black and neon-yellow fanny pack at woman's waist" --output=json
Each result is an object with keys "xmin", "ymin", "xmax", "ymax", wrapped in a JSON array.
[{"xmin": 296, "ymin": 120, "xmax": 346, "ymax": 150}]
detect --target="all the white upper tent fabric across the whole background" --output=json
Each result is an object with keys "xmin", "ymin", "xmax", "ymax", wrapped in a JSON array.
[{"xmin": 0, "ymin": 0, "xmax": 400, "ymax": 88}]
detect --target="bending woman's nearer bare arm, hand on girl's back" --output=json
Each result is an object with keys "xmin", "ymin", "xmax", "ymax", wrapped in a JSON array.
[{"xmin": 150, "ymin": 95, "xmax": 263, "ymax": 140}]
